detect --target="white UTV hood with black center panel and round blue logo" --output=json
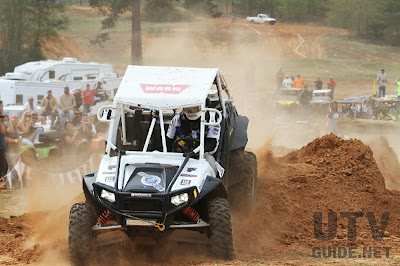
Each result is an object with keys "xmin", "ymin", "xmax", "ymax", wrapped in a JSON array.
[{"xmin": 96, "ymin": 153, "xmax": 215, "ymax": 193}]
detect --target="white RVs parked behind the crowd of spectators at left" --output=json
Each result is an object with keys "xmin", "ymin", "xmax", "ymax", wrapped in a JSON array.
[{"xmin": 0, "ymin": 57, "xmax": 121, "ymax": 105}]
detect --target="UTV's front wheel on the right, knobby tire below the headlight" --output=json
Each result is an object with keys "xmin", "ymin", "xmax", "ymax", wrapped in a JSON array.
[{"xmin": 208, "ymin": 197, "xmax": 235, "ymax": 260}]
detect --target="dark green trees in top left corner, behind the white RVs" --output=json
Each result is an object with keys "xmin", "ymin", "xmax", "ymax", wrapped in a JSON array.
[{"xmin": 0, "ymin": 0, "xmax": 69, "ymax": 74}]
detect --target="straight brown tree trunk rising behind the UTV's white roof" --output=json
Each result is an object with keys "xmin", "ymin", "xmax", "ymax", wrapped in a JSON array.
[{"xmin": 131, "ymin": 0, "xmax": 143, "ymax": 65}]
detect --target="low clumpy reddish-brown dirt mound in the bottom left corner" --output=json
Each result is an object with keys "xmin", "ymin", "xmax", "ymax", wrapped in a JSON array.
[{"xmin": 0, "ymin": 215, "xmax": 42, "ymax": 265}]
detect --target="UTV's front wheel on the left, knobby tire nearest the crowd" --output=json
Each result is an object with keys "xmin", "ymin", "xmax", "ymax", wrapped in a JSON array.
[{"xmin": 68, "ymin": 203, "xmax": 95, "ymax": 265}]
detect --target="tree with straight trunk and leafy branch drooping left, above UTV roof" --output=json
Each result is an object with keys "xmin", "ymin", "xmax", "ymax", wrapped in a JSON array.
[{"xmin": 89, "ymin": 0, "xmax": 143, "ymax": 65}]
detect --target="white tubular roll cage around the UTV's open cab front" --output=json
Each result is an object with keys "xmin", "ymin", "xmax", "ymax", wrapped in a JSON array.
[{"xmin": 97, "ymin": 73, "xmax": 233, "ymax": 159}]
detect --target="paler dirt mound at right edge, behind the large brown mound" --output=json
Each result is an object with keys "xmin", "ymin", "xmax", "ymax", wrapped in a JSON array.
[{"xmin": 368, "ymin": 137, "xmax": 400, "ymax": 190}]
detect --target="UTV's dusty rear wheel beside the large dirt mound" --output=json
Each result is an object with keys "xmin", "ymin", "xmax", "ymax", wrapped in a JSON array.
[{"xmin": 228, "ymin": 151, "xmax": 257, "ymax": 211}]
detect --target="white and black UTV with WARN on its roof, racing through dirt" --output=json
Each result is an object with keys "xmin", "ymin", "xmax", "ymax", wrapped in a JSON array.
[{"xmin": 68, "ymin": 66, "xmax": 257, "ymax": 265}]
